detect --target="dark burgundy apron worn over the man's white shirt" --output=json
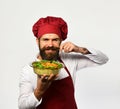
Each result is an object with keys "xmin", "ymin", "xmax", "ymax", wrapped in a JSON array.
[{"xmin": 36, "ymin": 60, "xmax": 77, "ymax": 109}]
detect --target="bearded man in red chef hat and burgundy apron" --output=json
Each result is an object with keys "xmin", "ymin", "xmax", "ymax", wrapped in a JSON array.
[{"xmin": 19, "ymin": 16, "xmax": 108, "ymax": 109}]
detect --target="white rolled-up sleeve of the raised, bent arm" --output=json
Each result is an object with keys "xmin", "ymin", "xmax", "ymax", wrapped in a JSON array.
[{"xmin": 75, "ymin": 48, "xmax": 109, "ymax": 70}]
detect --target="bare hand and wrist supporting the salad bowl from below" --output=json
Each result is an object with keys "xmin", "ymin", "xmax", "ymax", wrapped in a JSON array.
[{"xmin": 34, "ymin": 74, "xmax": 57, "ymax": 100}]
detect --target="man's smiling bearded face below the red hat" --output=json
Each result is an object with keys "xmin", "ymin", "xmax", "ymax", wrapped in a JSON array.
[{"xmin": 37, "ymin": 34, "xmax": 61, "ymax": 60}]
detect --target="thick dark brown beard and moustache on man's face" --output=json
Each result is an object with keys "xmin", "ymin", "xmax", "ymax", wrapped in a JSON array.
[{"xmin": 39, "ymin": 46, "xmax": 59, "ymax": 60}]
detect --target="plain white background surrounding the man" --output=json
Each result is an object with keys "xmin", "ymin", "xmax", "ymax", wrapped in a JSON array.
[{"xmin": 0, "ymin": 0, "xmax": 120, "ymax": 109}]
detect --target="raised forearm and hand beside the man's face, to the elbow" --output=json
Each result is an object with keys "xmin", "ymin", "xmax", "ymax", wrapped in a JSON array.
[{"xmin": 60, "ymin": 42, "xmax": 108, "ymax": 66}]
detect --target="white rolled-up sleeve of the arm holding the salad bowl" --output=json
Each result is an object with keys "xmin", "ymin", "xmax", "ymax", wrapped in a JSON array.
[{"xmin": 18, "ymin": 66, "xmax": 41, "ymax": 109}]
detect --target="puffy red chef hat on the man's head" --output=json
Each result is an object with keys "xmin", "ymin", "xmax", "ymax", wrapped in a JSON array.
[{"xmin": 32, "ymin": 16, "xmax": 68, "ymax": 40}]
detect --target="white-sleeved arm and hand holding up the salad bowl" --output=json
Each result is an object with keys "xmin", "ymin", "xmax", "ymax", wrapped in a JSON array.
[{"xmin": 18, "ymin": 65, "xmax": 56, "ymax": 109}]
